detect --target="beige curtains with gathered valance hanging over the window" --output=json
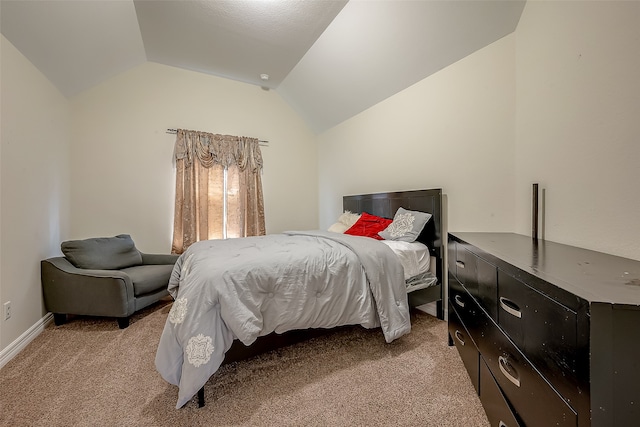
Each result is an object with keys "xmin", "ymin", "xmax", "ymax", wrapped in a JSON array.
[{"xmin": 171, "ymin": 129, "xmax": 265, "ymax": 254}]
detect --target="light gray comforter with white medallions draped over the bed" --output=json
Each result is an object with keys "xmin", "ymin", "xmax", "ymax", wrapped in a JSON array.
[{"xmin": 156, "ymin": 231, "xmax": 411, "ymax": 408}]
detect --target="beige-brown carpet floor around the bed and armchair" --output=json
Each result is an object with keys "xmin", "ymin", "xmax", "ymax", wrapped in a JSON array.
[{"xmin": 0, "ymin": 300, "xmax": 489, "ymax": 427}]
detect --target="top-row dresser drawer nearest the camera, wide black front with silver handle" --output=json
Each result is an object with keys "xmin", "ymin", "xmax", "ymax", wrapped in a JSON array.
[{"xmin": 498, "ymin": 270, "xmax": 578, "ymax": 381}]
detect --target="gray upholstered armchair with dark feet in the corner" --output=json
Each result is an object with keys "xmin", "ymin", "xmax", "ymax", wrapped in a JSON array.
[{"xmin": 40, "ymin": 234, "xmax": 178, "ymax": 329}]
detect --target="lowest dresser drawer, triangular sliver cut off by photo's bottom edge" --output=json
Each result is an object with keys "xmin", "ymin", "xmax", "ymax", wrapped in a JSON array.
[{"xmin": 480, "ymin": 357, "xmax": 521, "ymax": 427}]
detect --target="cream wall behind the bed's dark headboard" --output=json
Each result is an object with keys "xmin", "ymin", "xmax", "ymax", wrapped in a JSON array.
[{"xmin": 318, "ymin": 36, "xmax": 515, "ymax": 237}]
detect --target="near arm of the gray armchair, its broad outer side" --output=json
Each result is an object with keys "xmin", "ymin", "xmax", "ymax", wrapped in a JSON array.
[{"xmin": 40, "ymin": 257, "xmax": 135, "ymax": 317}]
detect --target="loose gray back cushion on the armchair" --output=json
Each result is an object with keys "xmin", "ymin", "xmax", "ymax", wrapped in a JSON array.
[{"xmin": 60, "ymin": 234, "xmax": 142, "ymax": 270}]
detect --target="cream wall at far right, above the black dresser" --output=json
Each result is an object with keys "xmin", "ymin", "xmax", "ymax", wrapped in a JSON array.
[{"xmin": 515, "ymin": 1, "xmax": 640, "ymax": 260}]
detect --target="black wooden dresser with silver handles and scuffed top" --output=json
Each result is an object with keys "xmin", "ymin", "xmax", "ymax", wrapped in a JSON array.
[{"xmin": 448, "ymin": 233, "xmax": 640, "ymax": 427}]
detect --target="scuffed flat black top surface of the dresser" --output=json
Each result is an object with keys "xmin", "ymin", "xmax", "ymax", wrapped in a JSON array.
[{"xmin": 449, "ymin": 232, "xmax": 640, "ymax": 307}]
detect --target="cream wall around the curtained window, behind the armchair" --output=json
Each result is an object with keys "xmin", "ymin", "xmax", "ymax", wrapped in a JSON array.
[{"xmin": 71, "ymin": 63, "xmax": 318, "ymax": 252}]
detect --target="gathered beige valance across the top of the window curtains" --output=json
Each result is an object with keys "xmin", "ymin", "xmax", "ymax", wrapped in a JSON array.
[{"xmin": 175, "ymin": 129, "xmax": 262, "ymax": 173}]
